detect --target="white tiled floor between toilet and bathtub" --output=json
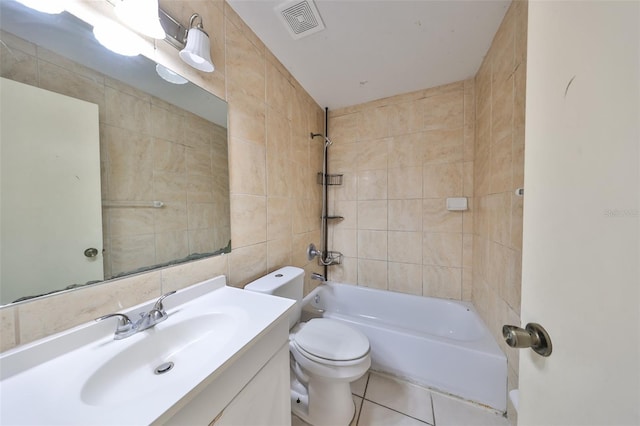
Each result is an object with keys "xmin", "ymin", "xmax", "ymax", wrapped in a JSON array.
[{"xmin": 291, "ymin": 372, "xmax": 509, "ymax": 426}]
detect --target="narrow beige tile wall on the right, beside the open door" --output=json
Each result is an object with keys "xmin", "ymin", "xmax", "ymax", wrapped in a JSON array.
[{"xmin": 472, "ymin": 0, "xmax": 528, "ymax": 423}]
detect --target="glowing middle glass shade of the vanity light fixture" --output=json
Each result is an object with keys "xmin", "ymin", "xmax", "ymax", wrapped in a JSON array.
[{"xmin": 115, "ymin": 0, "xmax": 166, "ymax": 40}]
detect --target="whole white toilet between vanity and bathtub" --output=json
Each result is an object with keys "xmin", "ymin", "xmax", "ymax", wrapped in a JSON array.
[{"xmin": 245, "ymin": 266, "xmax": 371, "ymax": 426}]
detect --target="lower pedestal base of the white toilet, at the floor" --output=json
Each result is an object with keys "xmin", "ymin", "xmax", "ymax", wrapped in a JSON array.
[{"xmin": 291, "ymin": 380, "xmax": 355, "ymax": 426}]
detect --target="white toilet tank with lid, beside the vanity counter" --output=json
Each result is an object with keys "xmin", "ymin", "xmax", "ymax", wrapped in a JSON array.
[{"xmin": 244, "ymin": 266, "xmax": 304, "ymax": 328}]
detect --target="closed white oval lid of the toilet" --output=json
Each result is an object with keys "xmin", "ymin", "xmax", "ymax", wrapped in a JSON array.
[{"xmin": 293, "ymin": 318, "xmax": 369, "ymax": 361}]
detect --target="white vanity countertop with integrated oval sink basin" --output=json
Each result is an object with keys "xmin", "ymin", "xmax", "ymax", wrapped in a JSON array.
[{"xmin": 0, "ymin": 277, "xmax": 293, "ymax": 425}]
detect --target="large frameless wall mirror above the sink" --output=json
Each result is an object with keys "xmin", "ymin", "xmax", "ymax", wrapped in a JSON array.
[{"xmin": 0, "ymin": 0, "xmax": 231, "ymax": 305}]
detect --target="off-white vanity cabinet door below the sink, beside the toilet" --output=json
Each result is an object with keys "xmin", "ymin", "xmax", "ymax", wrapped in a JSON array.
[{"xmin": 211, "ymin": 345, "xmax": 291, "ymax": 426}]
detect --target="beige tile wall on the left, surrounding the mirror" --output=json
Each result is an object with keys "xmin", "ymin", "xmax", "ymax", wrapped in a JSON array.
[{"xmin": 0, "ymin": 0, "xmax": 324, "ymax": 350}]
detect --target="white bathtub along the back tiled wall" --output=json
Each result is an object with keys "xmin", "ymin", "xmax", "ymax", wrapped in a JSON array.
[{"xmin": 305, "ymin": 282, "xmax": 507, "ymax": 411}]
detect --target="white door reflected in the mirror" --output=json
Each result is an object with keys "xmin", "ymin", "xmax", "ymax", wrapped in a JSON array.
[{"xmin": 0, "ymin": 78, "xmax": 104, "ymax": 304}]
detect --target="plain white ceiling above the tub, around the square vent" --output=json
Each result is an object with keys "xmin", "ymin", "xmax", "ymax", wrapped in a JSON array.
[{"xmin": 228, "ymin": 0, "xmax": 511, "ymax": 109}]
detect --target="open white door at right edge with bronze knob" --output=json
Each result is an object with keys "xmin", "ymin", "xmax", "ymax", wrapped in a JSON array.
[{"xmin": 514, "ymin": 0, "xmax": 640, "ymax": 426}]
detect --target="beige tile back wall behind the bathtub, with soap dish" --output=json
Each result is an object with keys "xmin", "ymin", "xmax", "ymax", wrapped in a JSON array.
[{"xmin": 329, "ymin": 79, "xmax": 475, "ymax": 300}]
